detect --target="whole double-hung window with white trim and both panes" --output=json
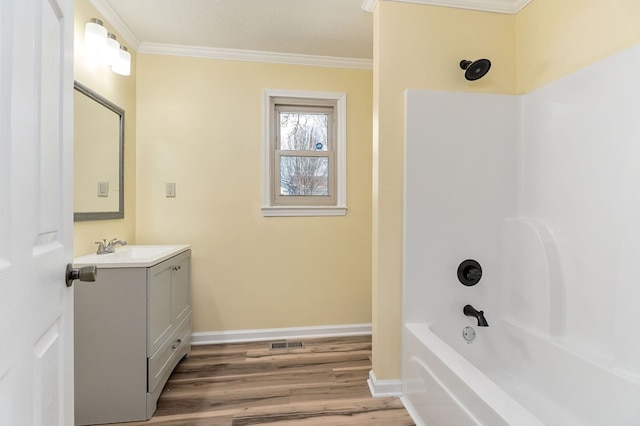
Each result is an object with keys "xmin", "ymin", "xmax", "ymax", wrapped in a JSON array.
[{"xmin": 262, "ymin": 90, "xmax": 347, "ymax": 216}]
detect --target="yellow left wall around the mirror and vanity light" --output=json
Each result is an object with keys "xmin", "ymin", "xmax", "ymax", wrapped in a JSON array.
[{"xmin": 73, "ymin": 0, "xmax": 136, "ymax": 256}]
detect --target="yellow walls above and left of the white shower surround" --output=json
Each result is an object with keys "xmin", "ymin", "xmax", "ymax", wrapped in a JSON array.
[{"xmin": 372, "ymin": 0, "xmax": 640, "ymax": 380}]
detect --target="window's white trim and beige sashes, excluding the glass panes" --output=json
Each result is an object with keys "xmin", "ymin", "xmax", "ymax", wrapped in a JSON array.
[{"xmin": 262, "ymin": 89, "xmax": 347, "ymax": 216}]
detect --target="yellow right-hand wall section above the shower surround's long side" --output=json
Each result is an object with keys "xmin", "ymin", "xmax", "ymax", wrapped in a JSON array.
[{"xmin": 516, "ymin": 0, "xmax": 640, "ymax": 93}]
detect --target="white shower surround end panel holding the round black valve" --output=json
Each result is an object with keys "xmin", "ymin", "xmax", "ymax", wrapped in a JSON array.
[{"xmin": 404, "ymin": 91, "xmax": 520, "ymax": 328}]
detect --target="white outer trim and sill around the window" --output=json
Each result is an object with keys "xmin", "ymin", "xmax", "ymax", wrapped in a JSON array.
[{"xmin": 262, "ymin": 89, "xmax": 347, "ymax": 216}]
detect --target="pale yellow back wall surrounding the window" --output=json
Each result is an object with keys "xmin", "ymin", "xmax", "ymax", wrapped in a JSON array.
[{"xmin": 136, "ymin": 54, "xmax": 372, "ymax": 331}]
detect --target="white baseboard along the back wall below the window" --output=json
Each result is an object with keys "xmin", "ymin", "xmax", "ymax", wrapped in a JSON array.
[{"xmin": 191, "ymin": 324, "xmax": 371, "ymax": 345}]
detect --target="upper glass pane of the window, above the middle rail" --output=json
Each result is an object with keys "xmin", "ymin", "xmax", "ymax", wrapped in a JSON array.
[{"xmin": 278, "ymin": 112, "xmax": 329, "ymax": 151}]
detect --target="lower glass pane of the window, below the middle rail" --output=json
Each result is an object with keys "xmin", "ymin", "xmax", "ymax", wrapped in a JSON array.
[{"xmin": 280, "ymin": 156, "xmax": 329, "ymax": 195}]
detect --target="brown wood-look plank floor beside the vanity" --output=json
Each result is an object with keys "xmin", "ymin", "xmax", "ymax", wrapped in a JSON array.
[{"xmin": 107, "ymin": 336, "xmax": 415, "ymax": 426}]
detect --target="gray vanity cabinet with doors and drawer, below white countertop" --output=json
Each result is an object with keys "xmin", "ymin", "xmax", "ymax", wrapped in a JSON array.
[{"xmin": 74, "ymin": 250, "xmax": 191, "ymax": 425}]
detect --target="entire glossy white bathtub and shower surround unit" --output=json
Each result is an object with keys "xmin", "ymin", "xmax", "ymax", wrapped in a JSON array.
[{"xmin": 402, "ymin": 46, "xmax": 640, "ymax": 425}]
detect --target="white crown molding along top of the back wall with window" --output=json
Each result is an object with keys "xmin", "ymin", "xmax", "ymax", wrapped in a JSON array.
[{"xmin": 138, "ymin": 42, "xmax": 373, "ymax": 70}]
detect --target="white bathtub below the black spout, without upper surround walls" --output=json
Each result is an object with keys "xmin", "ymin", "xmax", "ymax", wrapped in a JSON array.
[{"xmin": 402, "ymin": 319, "xmax": 640, "ymax": 426}]
